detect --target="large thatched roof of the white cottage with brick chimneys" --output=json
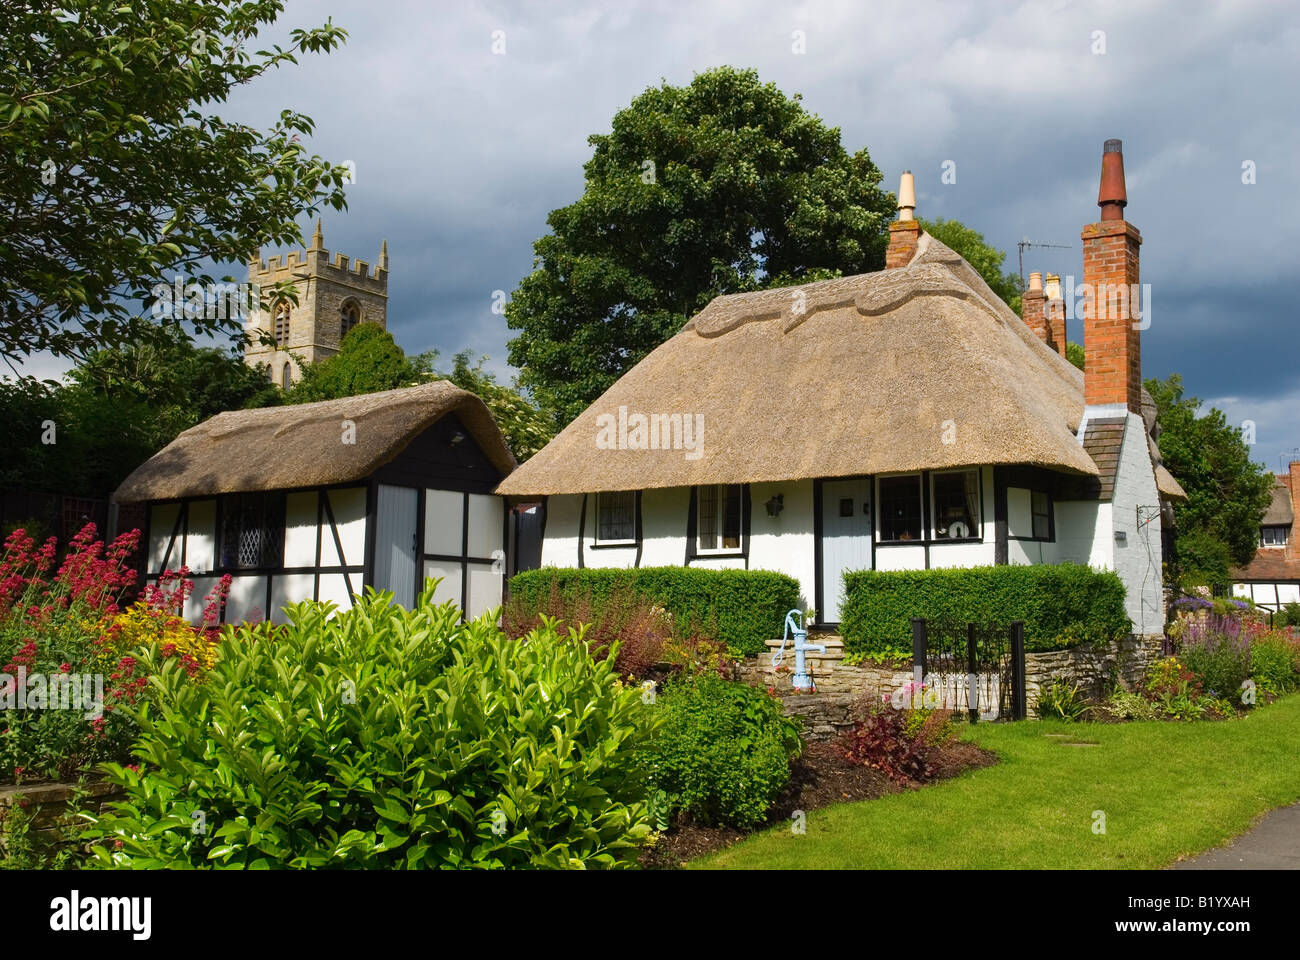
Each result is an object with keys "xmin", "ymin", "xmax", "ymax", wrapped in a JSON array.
[{"xmin": 498, "ymin": 233, "xmax": 1177, "ymax": 496}]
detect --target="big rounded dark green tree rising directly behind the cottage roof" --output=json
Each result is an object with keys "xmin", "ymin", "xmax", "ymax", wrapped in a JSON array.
[{"xmin": 506, "ymin": 68, "xmax": 894, "ymax": 423}]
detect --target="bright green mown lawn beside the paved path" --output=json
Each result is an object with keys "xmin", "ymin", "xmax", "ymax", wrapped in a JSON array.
[{"xmin": 689, "ymin": 695, "xmax": 1300, "ymax": 869}]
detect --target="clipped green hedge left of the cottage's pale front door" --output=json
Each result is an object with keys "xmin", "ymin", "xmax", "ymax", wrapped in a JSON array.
[{"xmin": 510, "ymin": 567, "xmax": 800, "ymax": 654}]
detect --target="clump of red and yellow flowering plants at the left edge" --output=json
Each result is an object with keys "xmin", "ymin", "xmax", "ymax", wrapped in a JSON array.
[{"xmin": 0, "ymin": 524, "xmax": 229, "ymax": 782}]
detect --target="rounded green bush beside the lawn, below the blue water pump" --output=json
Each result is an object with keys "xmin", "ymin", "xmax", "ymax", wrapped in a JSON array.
[{"xmin": 647, "ymin": 674, "xmax": 802, "ymax": 830}]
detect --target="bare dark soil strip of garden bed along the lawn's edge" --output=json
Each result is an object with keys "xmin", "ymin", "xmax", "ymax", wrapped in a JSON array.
[{"xmin": 641, "ymin": 740, "xmax": 997, "ymax": 870}]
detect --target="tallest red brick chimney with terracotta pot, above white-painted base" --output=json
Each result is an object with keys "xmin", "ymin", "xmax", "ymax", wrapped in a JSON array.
[{"xmin": 1083, "ymin": 140, "xmax": 1141, "ymax": 415}]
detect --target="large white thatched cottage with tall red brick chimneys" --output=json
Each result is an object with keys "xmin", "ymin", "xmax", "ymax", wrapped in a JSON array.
[{"xmin": 498, "ymin": 140, "xmax": 1183, "ymax": 633}]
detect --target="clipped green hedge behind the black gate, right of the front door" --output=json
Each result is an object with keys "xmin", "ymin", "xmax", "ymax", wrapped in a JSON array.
[{"xmin": 840, "ymin": 563, "xmax": 1132, "ymax": 658}]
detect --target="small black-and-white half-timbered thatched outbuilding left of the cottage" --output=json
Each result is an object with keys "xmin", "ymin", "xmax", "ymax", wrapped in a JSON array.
[{"xmin": 113, "ymin": 381, "xmax": 515, "ymax": 622}]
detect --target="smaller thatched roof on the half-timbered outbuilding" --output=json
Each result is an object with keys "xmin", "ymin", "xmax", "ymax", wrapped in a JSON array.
[{"xmin": 113, "ymin": 380, "xmax": 515, "ymax": 503}]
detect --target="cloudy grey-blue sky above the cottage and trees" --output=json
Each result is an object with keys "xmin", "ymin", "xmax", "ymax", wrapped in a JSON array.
[{"xmin": 20, "ymin": 0, "xmax": 1300, "ymax": 470}]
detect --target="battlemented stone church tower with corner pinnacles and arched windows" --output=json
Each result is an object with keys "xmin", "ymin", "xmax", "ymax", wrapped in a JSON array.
[{"xmin": 244, "ymin": 220, "xmax": 389, "ymax": 386}]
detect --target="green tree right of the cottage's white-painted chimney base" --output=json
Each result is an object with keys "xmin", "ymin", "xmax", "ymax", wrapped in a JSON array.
[{"xmin": 1145, "ymin": 373, "xmax": 1273, "ymax": 588}]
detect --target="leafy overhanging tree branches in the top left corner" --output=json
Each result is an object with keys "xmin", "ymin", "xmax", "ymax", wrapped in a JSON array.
[{"xmin": 0, "ymin": 0, "xmax": 346, "ymax": 362}]
